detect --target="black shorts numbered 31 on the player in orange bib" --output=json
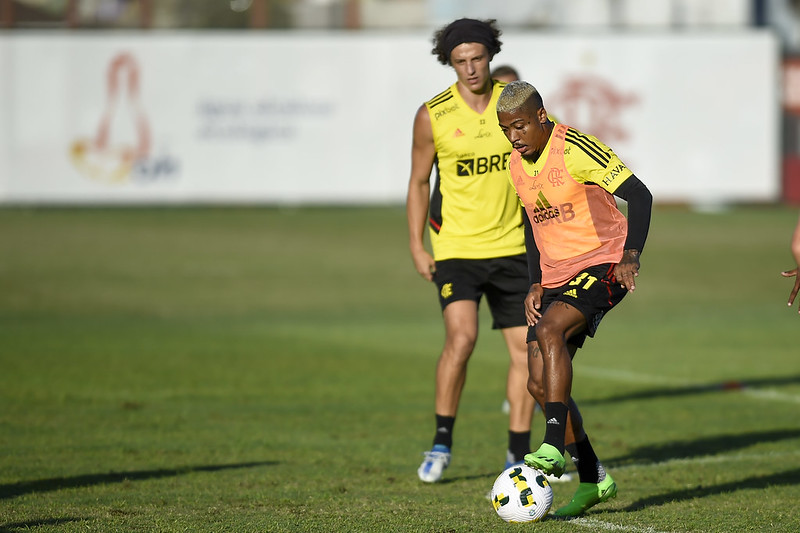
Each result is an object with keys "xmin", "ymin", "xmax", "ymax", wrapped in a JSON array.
[{"xmin": 528, "ymin": 263, "xmax": 628, "ymax": 348}]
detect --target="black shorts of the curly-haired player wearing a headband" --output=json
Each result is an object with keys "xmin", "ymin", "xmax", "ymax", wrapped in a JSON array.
[{"xmin": 433, "ymin": 254, "xmax": 530, "ymax": 329}]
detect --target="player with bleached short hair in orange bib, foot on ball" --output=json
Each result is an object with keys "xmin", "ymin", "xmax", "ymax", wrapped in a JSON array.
[{"xmin": 497, "ymin": 81, "xmax": 653, "ymax": 516}]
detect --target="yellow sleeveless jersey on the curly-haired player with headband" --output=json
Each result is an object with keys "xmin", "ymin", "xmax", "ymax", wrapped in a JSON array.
[{"xmin": 425, "ymin": 81, "xmax": 525, "ymax": 261}]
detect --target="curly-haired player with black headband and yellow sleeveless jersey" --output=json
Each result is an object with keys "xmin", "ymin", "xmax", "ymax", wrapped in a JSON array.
[{"xmin": 406, "ymin": 19, "xmax": 534, "ymax": 483}]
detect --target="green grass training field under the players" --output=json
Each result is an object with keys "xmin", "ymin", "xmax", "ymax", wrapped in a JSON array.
[{"xmin": 0, "ymin": 202, "xmax": 800, "ymax": 533}]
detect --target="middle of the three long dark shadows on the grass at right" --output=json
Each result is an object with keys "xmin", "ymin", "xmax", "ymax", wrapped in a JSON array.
[{"xmin": 603, "ymin": 428, "xmax": 800, "ymax": 466}]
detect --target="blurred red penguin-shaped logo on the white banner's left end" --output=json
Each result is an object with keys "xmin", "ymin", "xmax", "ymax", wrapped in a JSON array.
[{"xmin": 70, "ymin": 53, "xmax": 155, "ymax": 182}]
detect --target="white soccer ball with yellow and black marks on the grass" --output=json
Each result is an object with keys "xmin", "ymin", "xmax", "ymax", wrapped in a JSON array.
[{"xmin": 492, "ymin": 465, "xmax": 553, "ymax": 522}]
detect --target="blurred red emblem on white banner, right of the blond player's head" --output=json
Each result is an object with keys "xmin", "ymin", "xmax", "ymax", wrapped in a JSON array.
[{"xmin": 547, "ymin": 76, "xmax": 639, "ymax": 145}]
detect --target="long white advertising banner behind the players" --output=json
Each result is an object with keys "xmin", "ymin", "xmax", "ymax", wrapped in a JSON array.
[{"xmin": 0, "ymin": 32, "xmax": 780, "ymax": 204}]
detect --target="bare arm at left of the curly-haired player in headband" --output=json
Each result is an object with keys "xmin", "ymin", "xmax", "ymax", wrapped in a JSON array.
[{"xmin": 406, "ymin": 105, "xmax": 436, "ymax": 281}]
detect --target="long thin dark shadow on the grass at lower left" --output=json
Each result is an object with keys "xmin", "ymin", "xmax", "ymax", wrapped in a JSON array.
[{"xmin": 0, "ymin": 461, "xmax": 278, "ymax": 500}]
